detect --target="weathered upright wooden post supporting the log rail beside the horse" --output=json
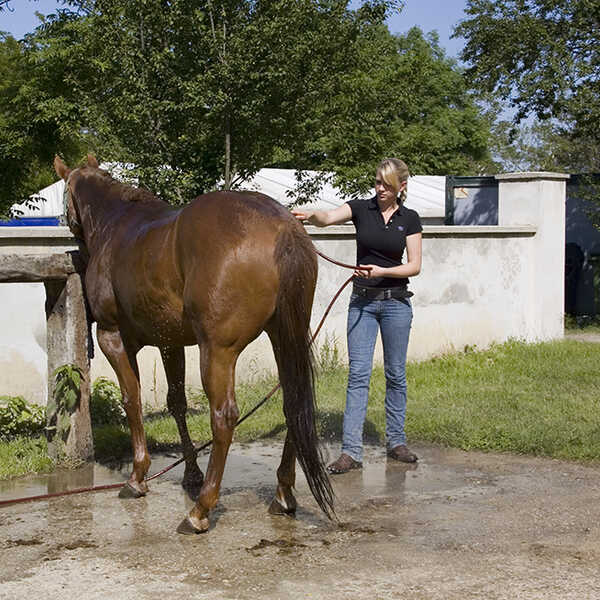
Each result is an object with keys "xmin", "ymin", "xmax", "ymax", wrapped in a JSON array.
[{"xmin": 44, "ymin": 273, "xmax": 94, "ymax": 461}]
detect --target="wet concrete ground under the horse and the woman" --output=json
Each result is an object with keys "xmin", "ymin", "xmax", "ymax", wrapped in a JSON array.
[{"xmin": 0, "ymin": 444, "xmax": 600, "ymax": 600}]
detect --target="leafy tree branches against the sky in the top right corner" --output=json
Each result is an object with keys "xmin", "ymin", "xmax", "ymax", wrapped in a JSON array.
[{"xmin": 454, "ymin": 0, "xmax": 600, "ymax": 171}]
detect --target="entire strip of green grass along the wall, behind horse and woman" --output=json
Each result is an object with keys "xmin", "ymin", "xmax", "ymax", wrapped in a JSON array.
[{"xmin": 0, "ymin": 339, "xmax": 600, "ymax": 477}]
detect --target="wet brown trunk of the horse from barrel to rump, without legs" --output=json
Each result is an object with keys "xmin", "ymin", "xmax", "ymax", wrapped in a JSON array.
[{"xmin": 96, "ymin": 192, "xmax": 310, "ymax": 346}]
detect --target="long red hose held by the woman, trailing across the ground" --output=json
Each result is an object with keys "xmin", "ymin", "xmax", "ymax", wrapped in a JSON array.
[{"xmin": 0, "ymin": 248, "xmax": 358, "ymax": 507}]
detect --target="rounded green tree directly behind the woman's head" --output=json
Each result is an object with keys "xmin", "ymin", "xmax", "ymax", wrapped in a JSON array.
[{"xmin": 298, "ymin": 23, "xmax": 491, "ymax": 195}]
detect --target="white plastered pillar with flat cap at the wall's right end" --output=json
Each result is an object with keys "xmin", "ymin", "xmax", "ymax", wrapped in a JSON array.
[{"xmin": 496, "ymin": 172, "xmax": 569, "ymax": 340}]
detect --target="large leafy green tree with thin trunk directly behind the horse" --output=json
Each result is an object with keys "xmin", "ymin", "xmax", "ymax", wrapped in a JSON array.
[{"xmin": 28, "ymin": 0, "xmax": 404, "ymax": 202}]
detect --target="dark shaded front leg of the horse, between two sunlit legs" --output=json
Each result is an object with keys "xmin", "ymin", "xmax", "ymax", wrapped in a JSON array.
[{"xmin": 160, "ymin": 348, "xmax": 204, "ymax": 500}]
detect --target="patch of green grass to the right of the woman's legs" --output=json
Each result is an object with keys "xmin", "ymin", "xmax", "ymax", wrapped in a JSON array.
[{"xmin": 406, "ymin": 340, "xmax": 600, "ymax": 460}]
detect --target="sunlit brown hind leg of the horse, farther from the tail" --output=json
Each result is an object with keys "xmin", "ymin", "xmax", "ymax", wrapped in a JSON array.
[{"xmin": 177, "ymin": 346, "xmax": 239, "ymax": 534}]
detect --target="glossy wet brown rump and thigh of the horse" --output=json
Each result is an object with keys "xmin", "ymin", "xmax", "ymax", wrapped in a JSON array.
[{"xmin": 176, "ymin": 192, "xmax": 312, "ymax": 345}]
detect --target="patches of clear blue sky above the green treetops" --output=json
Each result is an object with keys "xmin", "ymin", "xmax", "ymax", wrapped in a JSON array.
[{"xmin": 0, "ymin": 0, "xmax": 466, "ymax": 57}]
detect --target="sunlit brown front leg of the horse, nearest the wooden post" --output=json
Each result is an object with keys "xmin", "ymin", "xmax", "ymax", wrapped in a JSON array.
[{"xmin": 96, "ymin": 328, "xmax": 150, "ymax": 498}]
